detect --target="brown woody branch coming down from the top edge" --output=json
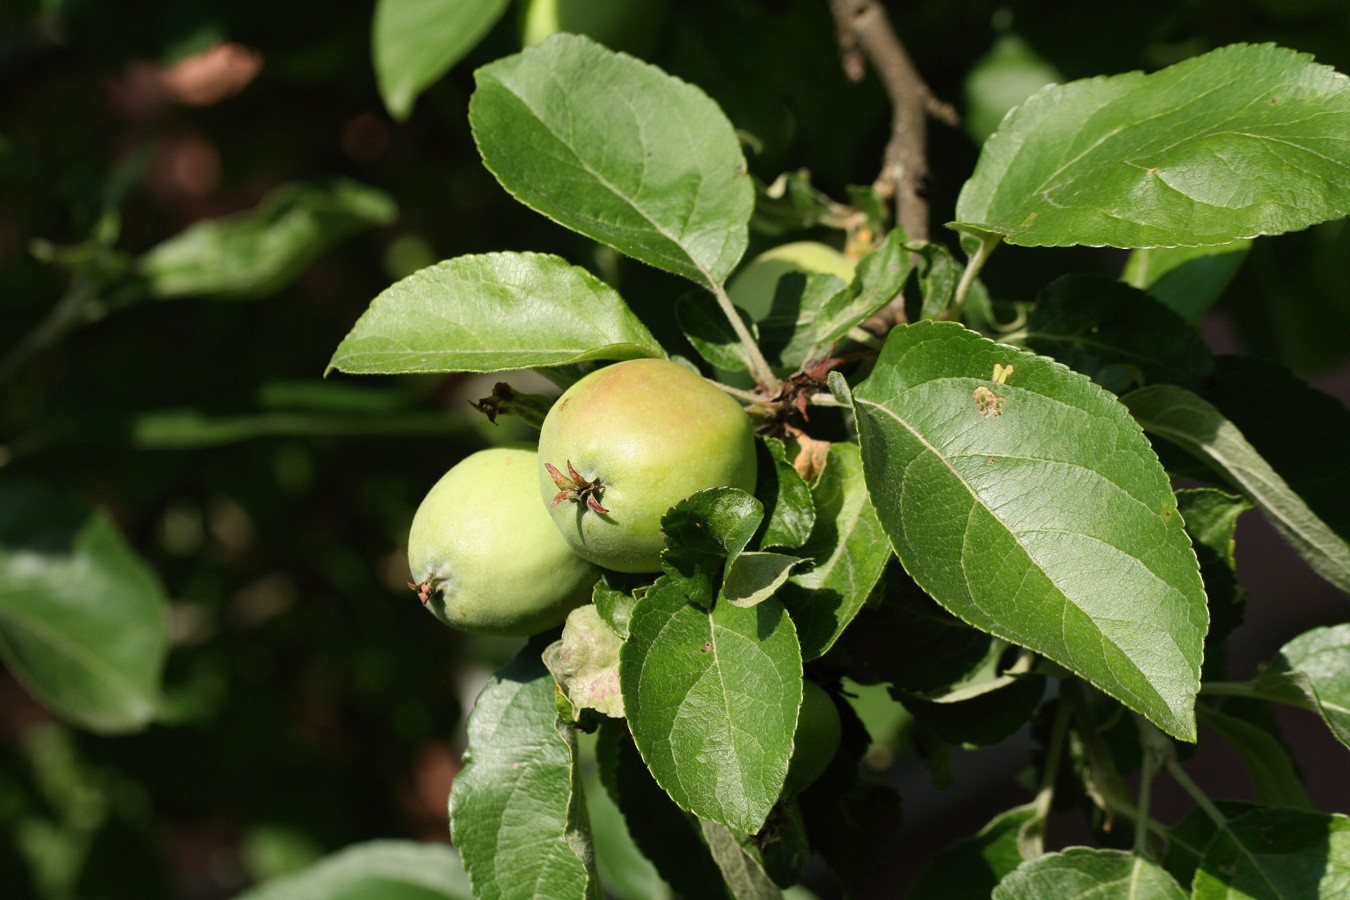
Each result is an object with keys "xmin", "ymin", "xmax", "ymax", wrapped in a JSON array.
[{"xmin": 830, "ymin": 0, "xmax": 957, "ymax": 335}]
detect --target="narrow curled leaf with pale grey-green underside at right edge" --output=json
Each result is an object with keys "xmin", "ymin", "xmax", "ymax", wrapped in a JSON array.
[{"xmin": 1121, "ymin": 385, "xmax": 1350, "ymax": 594}]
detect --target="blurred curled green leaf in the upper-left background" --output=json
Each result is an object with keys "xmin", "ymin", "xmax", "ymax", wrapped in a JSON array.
[{"xmin": 138, "ymin": 181, "xmax": 397, "ymax": 300}]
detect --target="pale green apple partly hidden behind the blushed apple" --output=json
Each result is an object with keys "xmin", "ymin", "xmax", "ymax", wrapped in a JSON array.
[{"xmin": 408, "ymin": 445, "xmax": 599, "ymax": 637}]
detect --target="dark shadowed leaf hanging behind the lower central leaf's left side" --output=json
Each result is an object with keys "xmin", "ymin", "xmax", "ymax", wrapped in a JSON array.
[{"xmin": 595, "ymin": 721, "xmax": 728, "ymax": 900}]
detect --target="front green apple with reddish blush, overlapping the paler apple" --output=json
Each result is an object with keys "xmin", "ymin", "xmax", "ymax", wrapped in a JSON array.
[{"xmin": 539, "ymin": 359, "xmax": 756, "ymax": 572}]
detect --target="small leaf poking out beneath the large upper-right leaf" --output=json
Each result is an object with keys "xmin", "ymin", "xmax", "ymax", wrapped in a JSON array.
[{"xmin": 1122, "ymin": 240, "xmax": 1251, "ymax": 324}]
